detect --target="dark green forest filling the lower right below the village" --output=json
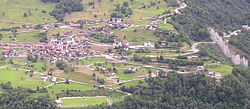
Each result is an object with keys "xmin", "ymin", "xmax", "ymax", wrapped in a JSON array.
[{"xmin": 89, "ymin": 66, "xmax": 250, "ymax": 109}]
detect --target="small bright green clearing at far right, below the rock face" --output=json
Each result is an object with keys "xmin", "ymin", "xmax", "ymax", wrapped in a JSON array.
[{"xmin": 206, "ymin": 64, "xmax": 233, "ymax": 76}]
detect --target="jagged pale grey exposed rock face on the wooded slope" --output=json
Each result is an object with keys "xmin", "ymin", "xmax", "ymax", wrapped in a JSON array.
[{"xmin": 209, "ymin": 28, "xmax": 248, "ymax": 67}]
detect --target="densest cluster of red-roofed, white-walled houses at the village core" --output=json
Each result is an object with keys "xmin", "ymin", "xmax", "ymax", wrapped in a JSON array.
[{"xmin": 28, "ymin": 32, "xmax": 90, "ymax": 63}]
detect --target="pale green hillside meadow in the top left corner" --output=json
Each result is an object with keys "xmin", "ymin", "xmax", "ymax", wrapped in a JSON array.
[{"xmin": 0, "ymin": 0, "xmax": 55, "ymax": 23}]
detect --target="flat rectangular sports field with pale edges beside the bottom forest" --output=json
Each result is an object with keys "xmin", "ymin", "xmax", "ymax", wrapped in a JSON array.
[{"xmin": 62, "ymin": 97, "xmax": 108, "ymax": 106}]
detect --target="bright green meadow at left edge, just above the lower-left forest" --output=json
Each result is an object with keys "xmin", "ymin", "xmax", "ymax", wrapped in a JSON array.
[{"xmin": 0, "ymin": 69, "xmax": 50, "ymax": 89}]
